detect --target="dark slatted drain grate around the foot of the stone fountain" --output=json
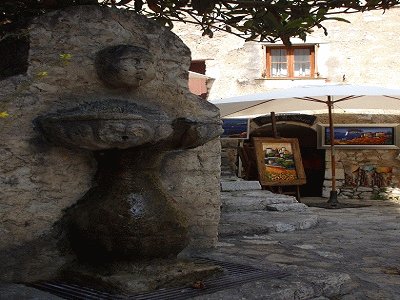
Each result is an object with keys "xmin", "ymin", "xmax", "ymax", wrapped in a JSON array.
[{"xmin": 30, "ymin": 258, "xmax": 289, "ymax": 300}]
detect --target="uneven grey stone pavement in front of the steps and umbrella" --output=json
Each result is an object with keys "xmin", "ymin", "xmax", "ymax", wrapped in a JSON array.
[{"xmin": 194, "ymin": 199, "xmax": 400, "ymax": 300}]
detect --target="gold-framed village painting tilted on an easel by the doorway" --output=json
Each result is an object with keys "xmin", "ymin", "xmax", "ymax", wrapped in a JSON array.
[{"xmin": 253, "ymin": 138, "xmax": 306, "ymax": 186}]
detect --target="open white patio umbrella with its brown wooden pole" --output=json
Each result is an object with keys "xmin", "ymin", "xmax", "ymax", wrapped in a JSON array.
[{"xmin": 210, "ymin": 84, "xmax": 400, "ymax": 205}]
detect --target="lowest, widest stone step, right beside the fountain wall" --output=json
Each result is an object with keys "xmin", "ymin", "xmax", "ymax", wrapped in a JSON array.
[{"xmin": 219, "ymin": 211, "xmax": 318, "ymax": 237}]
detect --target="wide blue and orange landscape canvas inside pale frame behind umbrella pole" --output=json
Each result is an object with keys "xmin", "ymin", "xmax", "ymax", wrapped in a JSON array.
[{"xmin": 324, "ymin": 126, "xmax": 395, "ymax": 146}]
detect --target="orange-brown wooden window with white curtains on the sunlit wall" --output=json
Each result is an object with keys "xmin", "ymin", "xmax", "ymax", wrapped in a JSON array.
[{"xmin": 265, "ymin": 46, "xmax": 315, "ymax": 78}]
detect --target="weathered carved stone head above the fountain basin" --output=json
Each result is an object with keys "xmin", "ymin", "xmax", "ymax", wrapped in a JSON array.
[{"xmin": 95, "ymin": 45, "xmax": 156, "ymax": 88}]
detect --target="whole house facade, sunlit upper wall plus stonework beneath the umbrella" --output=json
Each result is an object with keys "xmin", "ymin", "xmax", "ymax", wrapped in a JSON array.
[{"xmin": 175, "ymin": 8, "xmax": 400, "ymax": 198}]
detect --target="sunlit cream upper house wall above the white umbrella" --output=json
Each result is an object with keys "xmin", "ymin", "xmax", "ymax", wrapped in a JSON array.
[{"xmin": 174, "ymin": 8, "xmax": 400, "ymax": 99}]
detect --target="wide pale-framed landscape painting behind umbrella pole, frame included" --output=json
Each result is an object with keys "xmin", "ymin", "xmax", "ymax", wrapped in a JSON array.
[{"xmin": 317, "ymin": 124, "xmax": 399, "ymax": 149}]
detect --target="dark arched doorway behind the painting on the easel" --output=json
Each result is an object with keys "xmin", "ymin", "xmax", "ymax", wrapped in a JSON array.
[{"xmin": 250, "ymin": 123, "xmax": 325, "ymax": 197}]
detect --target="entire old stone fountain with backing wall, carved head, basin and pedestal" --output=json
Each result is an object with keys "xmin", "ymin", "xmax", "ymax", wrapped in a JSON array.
[{"xmin": 0, "ymin": 6, "xmax": 221, "ymax": 288}]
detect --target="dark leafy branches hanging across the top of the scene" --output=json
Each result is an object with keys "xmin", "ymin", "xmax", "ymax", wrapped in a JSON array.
[{"xmin": 0, "ymin": 0, "xmax": 400, "ymax": 44}]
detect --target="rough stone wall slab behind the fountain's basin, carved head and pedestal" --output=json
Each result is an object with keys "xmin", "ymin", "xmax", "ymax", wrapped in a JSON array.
[{"xmin": 0, "ymin": 6, "xmax": 220, "ymax": 281}]
